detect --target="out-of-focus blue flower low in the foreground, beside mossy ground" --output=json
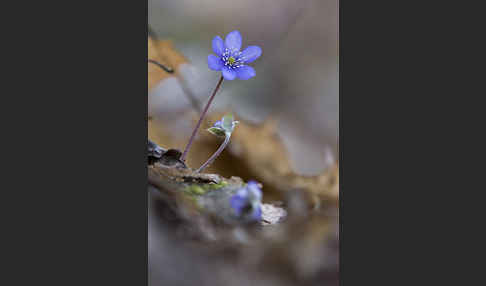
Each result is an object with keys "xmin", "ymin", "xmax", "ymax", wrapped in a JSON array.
[{"xmin": 230, "ymin": 181, "xmax": 262, "ymax": 221}]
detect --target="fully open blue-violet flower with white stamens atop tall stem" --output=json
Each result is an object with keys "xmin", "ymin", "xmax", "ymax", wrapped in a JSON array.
[{"xmin": 208, "ymin": 30, "xmax": 262, "ymax": 80}]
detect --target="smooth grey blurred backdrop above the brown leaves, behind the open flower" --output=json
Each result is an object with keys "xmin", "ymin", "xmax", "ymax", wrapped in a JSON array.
[{"xmin": 148, "ymin": 0, "xmax": 339, "ymax": 175}]
